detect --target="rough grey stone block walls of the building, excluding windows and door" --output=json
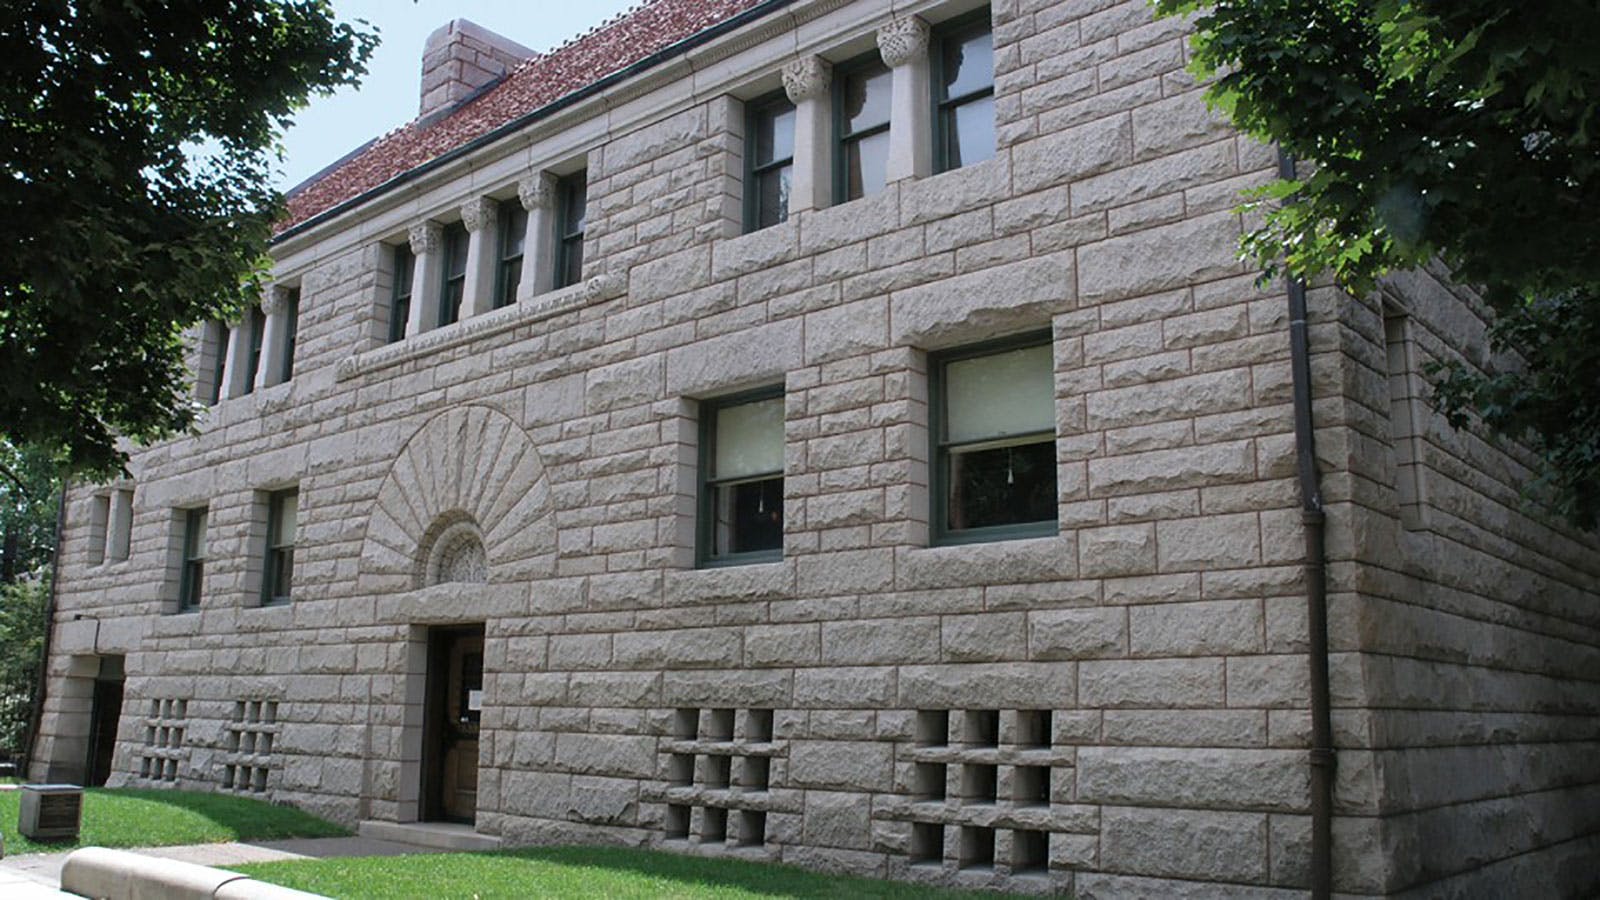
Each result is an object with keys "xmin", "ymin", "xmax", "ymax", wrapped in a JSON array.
[{"xmin": 32, "ymin": 0, "xmax": 1600, "ymax": 897}]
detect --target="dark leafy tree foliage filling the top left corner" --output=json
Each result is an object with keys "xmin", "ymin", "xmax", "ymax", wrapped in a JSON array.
[{"xmin": 0, "ymin": 0, "xmax": 376, "ymax": 476}]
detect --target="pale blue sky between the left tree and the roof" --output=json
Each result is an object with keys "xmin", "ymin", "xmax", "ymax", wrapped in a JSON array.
[{"xmin": 275, "ymin": 0, "xmax": 632, "ymax": 191}]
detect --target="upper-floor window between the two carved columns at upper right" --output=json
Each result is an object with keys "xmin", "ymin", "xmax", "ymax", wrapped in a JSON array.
[{"xmin": 834, "ymin": 51, "xmax": 894, "ymax": 203}]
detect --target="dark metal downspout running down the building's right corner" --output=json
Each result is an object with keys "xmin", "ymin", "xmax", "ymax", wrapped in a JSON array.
[{"xmin": 1278, "ymin": 147, "xmax": 1336, "ymax": 900}]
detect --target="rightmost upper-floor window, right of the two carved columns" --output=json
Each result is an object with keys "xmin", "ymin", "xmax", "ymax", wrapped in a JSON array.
[{"xmin": 931, "ymin": 10, "xmax": 995, "ymax": 171}]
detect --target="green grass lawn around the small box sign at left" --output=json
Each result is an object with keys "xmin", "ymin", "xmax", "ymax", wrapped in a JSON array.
[{"xmin": 0, "ymin": 788, "xmax": 349, "ymax": 854}]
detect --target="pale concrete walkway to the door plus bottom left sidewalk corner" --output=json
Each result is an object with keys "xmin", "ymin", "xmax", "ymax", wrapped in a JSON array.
[{"xmin": 0, "ymin": 838, "xmax": 443, "ymax": 900}]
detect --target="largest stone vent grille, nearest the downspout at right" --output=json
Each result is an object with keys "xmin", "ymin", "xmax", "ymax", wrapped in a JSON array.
[{"xmin": 886, "ymin": 709, "xmax": 1075, "ymax": 876}]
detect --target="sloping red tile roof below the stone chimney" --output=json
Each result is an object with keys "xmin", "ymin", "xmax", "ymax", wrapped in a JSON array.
[{"xmin": 277, "ymin": 0, "xmax": 763, "ymax": 234}]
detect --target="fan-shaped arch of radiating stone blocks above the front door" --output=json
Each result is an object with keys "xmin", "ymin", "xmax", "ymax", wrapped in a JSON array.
[{"xmin": 360, "ymin": 405, "xmax": 555, "ymax": 581}]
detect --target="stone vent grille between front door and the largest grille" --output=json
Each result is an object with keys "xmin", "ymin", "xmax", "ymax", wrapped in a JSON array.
[{"xmin": 661, "ymin": 708, "xmax": 774, "ymax": 847}]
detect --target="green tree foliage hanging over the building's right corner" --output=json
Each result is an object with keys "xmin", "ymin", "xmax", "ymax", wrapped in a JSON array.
[{"xmin": 1155, "ymin": 0, "xmax": 1600, "ymax": 527}]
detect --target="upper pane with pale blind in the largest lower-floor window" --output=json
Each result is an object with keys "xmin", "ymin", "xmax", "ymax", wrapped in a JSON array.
[{"xmin": 944, "ymin": 344, "xmax": 1056, "ymax": 442}]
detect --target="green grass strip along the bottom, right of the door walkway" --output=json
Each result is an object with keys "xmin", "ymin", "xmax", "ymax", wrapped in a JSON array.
[{"xmin": 230, "ymin": 847, "xmax": 997, "ymax": 900}]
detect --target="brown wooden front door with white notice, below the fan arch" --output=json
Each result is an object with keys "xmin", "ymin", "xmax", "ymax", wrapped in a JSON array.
[{"xmin": 422, "ymin": 625, "xmax": 483, "ymax": 823}]
